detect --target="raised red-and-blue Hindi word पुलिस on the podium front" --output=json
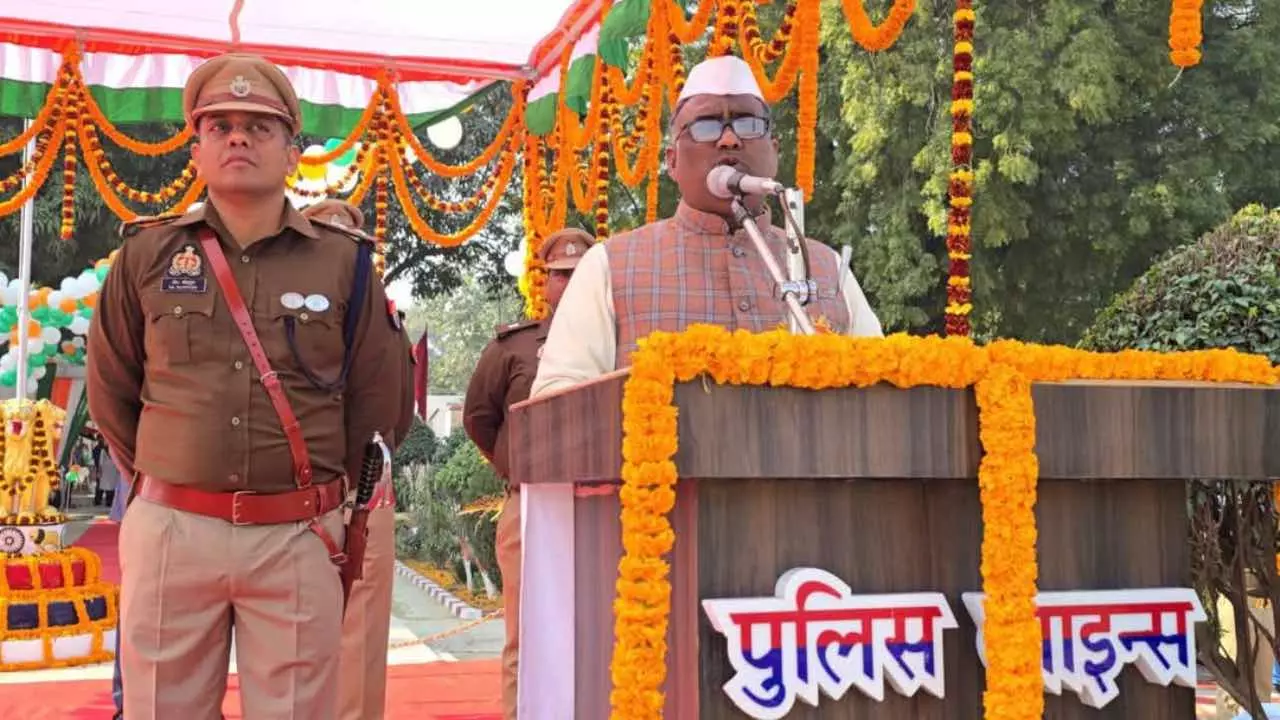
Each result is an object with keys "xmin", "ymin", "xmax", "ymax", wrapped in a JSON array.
[{"xmin": 703, "ymin": 568, "xmax": 957, "ymax": 720}]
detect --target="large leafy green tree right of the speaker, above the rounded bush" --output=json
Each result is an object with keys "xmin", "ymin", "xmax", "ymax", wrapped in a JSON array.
[{"xmin": 814, "ymin": 0, "xmax": 1280, "ymax": 341}]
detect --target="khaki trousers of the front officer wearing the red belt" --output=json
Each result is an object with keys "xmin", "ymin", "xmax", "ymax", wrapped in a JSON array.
[{"xmin": 120, "ymin": 498, "xmax": 343, "ymax": 720}]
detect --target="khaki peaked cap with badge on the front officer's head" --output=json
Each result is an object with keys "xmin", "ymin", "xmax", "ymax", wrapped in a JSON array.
[{"xmin": 182, "ymin": 53, "xmax": 302, "ymax": 135}]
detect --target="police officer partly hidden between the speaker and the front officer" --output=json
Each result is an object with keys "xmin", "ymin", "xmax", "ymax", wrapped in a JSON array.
[{"xmin": 462, "ymin": 228, "xmax": 594, "ymax": 720}]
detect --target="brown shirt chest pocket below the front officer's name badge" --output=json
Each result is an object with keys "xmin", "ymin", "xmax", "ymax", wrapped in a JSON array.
[{"xmin": 142, "ymin": 292, "xmax": 215, "ymax": 365}]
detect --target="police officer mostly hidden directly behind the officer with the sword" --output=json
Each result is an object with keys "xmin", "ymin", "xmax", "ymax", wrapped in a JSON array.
[{"xmin": 302, "ymin": 200, "xmax": 413, "ymax": 720}]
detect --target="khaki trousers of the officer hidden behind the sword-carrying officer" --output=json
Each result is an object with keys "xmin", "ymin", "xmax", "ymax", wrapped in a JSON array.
[{"xmin": 338, "ymin": 507, "xmax": 396, "ymax": 720}]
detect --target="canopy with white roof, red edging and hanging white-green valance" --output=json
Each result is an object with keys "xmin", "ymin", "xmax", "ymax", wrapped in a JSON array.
[{"xmin": 0, "ymin": 0, "xmax": 612, "ymax": 135}]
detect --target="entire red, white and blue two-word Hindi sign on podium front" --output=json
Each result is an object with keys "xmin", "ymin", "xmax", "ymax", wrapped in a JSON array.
[{"xmin": 703, "ymin": 568, "xmax": 1206, "ymax": 720}]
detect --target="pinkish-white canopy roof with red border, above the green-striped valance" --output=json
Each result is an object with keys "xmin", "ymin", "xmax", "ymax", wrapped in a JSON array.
[{"xmin": 0, "ymin": 0, "xmax": 604, "ymax": 83}]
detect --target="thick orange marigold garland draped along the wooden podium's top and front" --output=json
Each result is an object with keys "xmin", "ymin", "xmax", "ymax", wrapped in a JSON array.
[{"xmin": 611, "ymin": 325, "xmax": 1280, "ymax": 720}]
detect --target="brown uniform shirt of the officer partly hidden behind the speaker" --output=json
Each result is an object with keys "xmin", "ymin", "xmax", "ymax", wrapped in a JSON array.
[{"xmin": 462, "ymin": 320, "xmax": 550, "ymax": 479}]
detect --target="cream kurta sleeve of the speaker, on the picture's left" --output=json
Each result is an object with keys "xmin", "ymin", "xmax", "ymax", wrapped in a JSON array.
[{"xmin": 531, "ymin": 243, "xmax": 618, "ymax": 397}]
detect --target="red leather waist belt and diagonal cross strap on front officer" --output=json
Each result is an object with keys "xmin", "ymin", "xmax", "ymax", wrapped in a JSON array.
[{"xmin": 138, "ymin": 228, "xmax": 346, "ymax": 562}]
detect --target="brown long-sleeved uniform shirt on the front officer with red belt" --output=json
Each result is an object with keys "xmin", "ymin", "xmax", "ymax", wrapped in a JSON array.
[{"xmin": 86, "ymin": 200, "xmax": 413, "ymax": 492}]
